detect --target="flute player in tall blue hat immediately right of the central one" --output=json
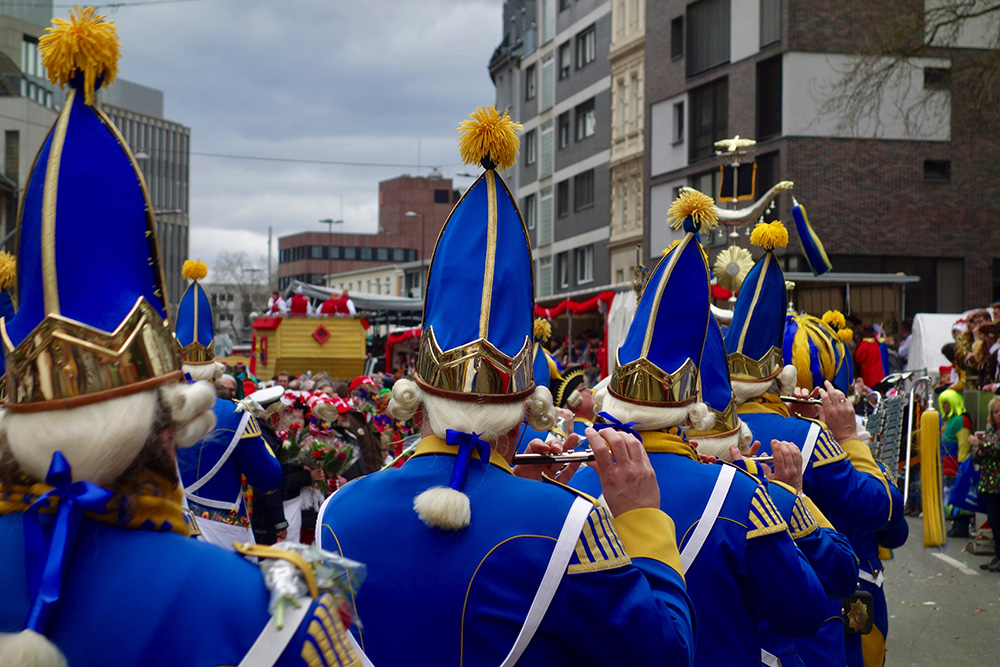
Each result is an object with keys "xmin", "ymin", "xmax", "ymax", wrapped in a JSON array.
[{"xmin": 572, "ymin": 191, "xmax": 826, "ymax": 667}]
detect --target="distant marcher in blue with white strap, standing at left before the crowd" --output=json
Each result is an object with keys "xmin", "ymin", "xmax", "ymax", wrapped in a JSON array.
[{"xmin": 177, "ymin": 259, "xmax": 281, "ymax": 549}]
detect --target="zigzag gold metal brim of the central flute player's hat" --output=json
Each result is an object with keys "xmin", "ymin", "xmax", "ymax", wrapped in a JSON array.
[{"xmin": 416, "ymin": 327, "xmax": 535, "ymax": 403}]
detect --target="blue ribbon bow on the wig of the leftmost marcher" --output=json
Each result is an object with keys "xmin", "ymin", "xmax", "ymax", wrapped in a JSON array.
[{"xmin": 24, "ymin": 451, "xmax": 112, "ymax": 635}]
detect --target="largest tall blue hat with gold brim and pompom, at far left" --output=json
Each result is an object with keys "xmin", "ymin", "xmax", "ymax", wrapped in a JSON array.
[{"xmin": 0, "ymin": 8, "xmax": 181, "ymax": 411}]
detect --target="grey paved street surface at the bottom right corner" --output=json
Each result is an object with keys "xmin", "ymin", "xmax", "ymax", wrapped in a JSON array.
[{"xmin": 885, "ymin": 515, "xmax": 1000, "ymax": 667}]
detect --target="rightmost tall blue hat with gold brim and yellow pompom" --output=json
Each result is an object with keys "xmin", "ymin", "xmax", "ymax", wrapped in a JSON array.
[{"xmin": 725, "ymin": 221, "xmax": 788, "ymax": 382}]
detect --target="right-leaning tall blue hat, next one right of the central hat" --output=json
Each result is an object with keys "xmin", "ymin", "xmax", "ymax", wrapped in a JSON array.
[{"xmin": 608, "ymin": 190, "xmax": 717, "ymax": 407}]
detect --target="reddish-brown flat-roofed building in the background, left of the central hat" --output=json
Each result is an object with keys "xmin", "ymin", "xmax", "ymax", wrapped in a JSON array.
[{"xmin": 278, "ymin": 171, "xmax": 461, "ymax": 293}]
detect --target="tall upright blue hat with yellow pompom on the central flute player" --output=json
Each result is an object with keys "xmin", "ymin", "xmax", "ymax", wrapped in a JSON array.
[{"xmin": 415, "ymin": 106, "xmax": 535, "ymax": 402}]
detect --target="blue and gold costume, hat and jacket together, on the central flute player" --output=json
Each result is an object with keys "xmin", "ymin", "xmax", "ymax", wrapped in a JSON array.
[{"xmin": 317, "ymin": 107, "xmax": 694, "ymax": 666}]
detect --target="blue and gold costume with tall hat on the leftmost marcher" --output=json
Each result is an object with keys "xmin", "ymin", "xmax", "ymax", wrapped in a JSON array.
[{"xmin": 0, "ymin": 8, "xmax": 357, "ymax": 667}]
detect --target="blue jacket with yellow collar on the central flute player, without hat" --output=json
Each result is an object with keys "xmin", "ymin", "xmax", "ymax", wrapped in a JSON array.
[{"xmin": 317, "ymin": 436, "xmax": 694, "ymax": 667}]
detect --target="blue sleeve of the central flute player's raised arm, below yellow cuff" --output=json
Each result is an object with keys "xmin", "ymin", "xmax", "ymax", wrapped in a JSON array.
[{"xmin": 559, "ymin": 558, "xmax": 695, "ymax": 666}]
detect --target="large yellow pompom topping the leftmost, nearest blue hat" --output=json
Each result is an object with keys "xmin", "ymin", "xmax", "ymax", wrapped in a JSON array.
[{"xmin": 38, "ymin": 7, "xmax": 121, "ymax": 104}]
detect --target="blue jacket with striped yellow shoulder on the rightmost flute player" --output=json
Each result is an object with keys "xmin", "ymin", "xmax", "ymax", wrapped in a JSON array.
[{"xmin": 738, "ymin": 395, "xmax": 892, "ymax": 536}]
